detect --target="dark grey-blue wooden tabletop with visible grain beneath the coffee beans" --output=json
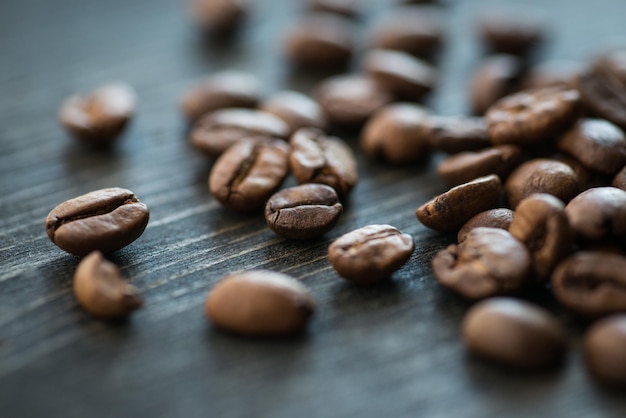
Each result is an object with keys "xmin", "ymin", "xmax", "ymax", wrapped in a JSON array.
[{"xmin": 0, "ymin": 0, "xmax": 626, "ymax": 418}]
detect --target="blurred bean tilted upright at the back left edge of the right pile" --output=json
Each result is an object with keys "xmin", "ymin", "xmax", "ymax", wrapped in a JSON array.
[{"xmin": 469, "ymin": 54, "xmax": 523, "ymax": 115}]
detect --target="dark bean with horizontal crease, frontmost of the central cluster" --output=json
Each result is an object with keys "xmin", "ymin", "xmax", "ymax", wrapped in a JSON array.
[{"xmin": 265, "ymin": 184, "xmax": 343, "ymax": 239}]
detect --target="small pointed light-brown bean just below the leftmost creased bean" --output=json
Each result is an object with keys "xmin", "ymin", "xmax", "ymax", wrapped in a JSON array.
[{"xmin": 74, "ymin": 251, "xmax": 143, "ymax": 319}]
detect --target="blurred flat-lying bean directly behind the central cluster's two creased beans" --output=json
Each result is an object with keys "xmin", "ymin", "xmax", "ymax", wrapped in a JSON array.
[{"xmin": 190, "ymin": 108, "xmax": 289, "ymax": 158}]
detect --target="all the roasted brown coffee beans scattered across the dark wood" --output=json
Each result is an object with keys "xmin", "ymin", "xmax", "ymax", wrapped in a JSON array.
[{"xmin": 46, "ymin": 0, "xmax": 626, "ymax": 383}]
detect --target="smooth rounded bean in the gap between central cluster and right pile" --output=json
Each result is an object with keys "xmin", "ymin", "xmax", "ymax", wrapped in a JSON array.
[{"xmin": 360, "ymin": 103, "xmax": 430, "ymax": 164}]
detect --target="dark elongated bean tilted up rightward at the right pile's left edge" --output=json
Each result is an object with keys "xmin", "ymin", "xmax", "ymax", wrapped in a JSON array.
[{"xmin": 415, "ymin": 175, "xmax": 502, "ymax": 231}]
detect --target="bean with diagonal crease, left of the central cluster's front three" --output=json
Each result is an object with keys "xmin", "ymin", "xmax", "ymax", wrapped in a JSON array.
[{"xmin": 209, "ymin": 137, "xmax": 289, "ymax": 211}]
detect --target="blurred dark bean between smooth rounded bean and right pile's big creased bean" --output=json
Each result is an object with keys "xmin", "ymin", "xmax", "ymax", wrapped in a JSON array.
[{"xmin": 428, "ymin": 116, "xmax": 491, "ymax": 154}]
